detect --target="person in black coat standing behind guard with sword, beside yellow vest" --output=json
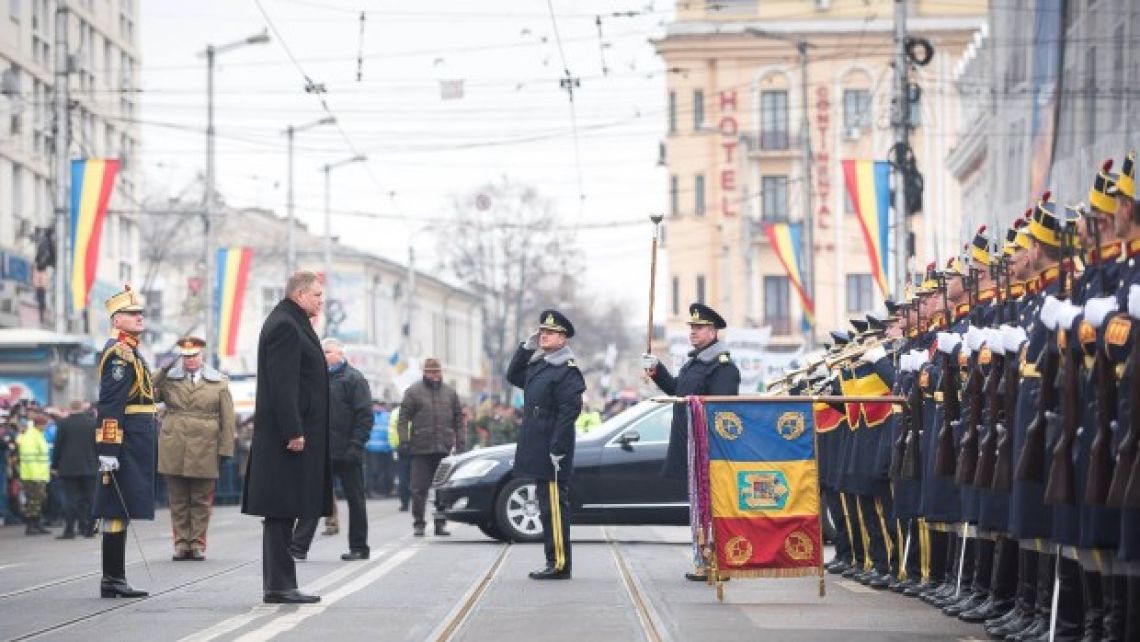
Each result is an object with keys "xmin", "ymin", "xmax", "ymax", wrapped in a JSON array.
[{"xmin": 51, "ymin": 400, "xmax": 99, "ymax": 539}]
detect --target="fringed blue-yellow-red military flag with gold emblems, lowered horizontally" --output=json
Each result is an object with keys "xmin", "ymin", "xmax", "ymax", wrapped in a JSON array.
[{"xmin": 690, "ymin": 399, "xmax": 823, "ymax": 592}]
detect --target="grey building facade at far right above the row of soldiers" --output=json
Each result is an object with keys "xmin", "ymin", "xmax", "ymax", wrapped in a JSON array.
[{"xmin": 947, "ymin": 0, "xmax": 1140, "ymax": 229}]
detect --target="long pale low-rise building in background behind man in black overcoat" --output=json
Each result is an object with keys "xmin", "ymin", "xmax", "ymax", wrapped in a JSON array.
[{"xmin": 140, "ymin": 200, "xmax": 486, "ymax": 400}]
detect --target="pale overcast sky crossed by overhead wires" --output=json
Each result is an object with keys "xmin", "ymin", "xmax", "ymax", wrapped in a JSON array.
[{"xmin": 139, "ymin": 0, "xmax": 673, "ymax": 323}]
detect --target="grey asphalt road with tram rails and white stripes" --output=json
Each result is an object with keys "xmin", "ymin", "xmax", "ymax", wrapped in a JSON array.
[{"xmin": 0, "ymin": 499, "xmax": 984, "ymax": 642}]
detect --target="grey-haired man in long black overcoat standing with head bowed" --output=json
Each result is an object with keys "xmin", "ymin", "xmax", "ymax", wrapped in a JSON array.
[{"xmin": 242, "ymin": 270, "xmax": 333, "ymax": 604}]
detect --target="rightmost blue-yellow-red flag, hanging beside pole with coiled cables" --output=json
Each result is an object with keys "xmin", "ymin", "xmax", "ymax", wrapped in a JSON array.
[{"xmin": 844, "ymin": 161, "xmax": 890, "ymax": 296}]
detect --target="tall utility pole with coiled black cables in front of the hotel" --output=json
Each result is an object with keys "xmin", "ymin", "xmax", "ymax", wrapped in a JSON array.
[{"xmin": 893, "ymin": 0, "xmax": 911, "ymax": 301}]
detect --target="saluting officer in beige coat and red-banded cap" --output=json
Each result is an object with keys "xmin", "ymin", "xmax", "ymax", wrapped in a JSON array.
[{"xmin": 154, "ymin": 336, "xmax": 235, "ymax": 561}]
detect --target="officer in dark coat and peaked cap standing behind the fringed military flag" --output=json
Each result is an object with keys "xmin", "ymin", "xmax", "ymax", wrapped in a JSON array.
[{"xmin": 642, "ymin": 303, "xmax": 740, "ymax": 582}]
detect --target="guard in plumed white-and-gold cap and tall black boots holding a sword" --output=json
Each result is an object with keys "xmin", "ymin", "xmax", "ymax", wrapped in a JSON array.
[{"xmin": 93, "ymin": 285, "xmax": 155, "ymax": 598}]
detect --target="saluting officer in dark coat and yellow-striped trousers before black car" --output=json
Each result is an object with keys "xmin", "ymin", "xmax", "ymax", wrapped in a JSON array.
[{"xmin": 506, "ymin": 310, "xmax": 586, "ymax": 579}]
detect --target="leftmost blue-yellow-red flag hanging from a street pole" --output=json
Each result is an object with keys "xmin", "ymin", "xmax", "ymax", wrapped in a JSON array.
[{"xmin": 71, "ymin": 159, "xmax": 119, "ymax": 310}]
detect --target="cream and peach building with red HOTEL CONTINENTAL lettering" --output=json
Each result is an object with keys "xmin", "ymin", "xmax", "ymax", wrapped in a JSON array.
[{"xmin": 656, "ymin": 0, "xmax": 986, "ymax": 350}]
